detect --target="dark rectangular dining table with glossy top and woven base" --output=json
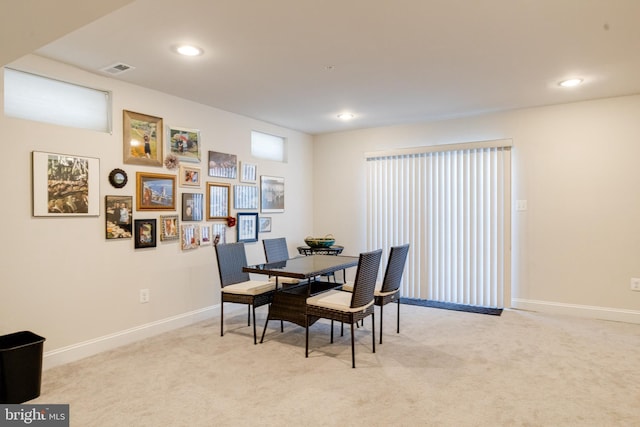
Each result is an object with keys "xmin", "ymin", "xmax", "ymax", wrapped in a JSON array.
[{"xmin": 243, "ymin": 255, "xmax": 359, "ymax": 342}]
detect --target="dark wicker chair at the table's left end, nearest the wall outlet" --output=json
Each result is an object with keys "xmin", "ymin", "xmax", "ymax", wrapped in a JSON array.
[{"xmin": 216, "ymin": 242, "xmax": 276, "ymax": 344}]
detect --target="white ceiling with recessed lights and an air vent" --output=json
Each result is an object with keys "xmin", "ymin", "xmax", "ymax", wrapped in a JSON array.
[{"xmin": 3, "ymin": 0, "xmax": 640, "ymax": 134}]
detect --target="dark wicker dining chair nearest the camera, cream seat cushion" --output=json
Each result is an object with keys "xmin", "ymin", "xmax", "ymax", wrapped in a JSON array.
[{"xmin": 305, "ymin": 249, "xmax": 382, "ymax": 368}]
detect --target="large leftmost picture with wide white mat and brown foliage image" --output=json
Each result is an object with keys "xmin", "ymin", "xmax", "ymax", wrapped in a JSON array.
[{"xmin": 31, "ymin": 151, "xmax": 100, "ymax": 216}]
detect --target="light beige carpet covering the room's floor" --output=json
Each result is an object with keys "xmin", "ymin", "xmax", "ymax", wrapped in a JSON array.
[{"xmin": 29, "ymin": 305, "xmax": 640, "ymax": 427}]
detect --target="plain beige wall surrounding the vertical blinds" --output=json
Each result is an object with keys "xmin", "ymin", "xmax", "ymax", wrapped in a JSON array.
[{"xmin": 314, "ymin": 96, "xmax": 640, "ymax": 323}]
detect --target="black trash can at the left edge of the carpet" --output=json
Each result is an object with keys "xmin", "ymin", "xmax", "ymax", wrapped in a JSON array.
[{"xmin": 0, "ymin": 331, "xmax": 45, "ymax": 403}]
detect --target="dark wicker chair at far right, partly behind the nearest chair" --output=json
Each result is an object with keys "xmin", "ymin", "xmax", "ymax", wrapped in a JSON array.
[{"xmin": 342, "ymin": 243, "xmax": 409, "ymax": 344}]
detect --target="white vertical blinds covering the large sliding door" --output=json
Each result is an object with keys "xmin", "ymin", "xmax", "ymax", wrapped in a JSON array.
[{"xmin": 366, "ymin": 140, "xmax": 511, "ymax": 308}]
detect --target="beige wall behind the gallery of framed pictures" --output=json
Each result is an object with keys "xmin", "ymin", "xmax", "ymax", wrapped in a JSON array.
[{"xmin": 0, "ymin": 56, "xmax": 313, "ymax": 362}]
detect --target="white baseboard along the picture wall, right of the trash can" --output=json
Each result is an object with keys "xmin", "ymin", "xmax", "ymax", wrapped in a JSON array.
[{"xmin": 42, "ymin": 304, "xmax": 220, "ymax": 369}]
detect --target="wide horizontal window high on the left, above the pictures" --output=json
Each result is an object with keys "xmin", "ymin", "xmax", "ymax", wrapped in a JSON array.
[{"xmin": 4, "ymin": 68, "xmax": 111, "ymax": 132}]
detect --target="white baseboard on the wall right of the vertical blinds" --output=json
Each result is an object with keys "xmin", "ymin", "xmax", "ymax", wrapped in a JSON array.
[{"xmin": 511, "ymin": 298, "xmax": 640, "ymax": 324}]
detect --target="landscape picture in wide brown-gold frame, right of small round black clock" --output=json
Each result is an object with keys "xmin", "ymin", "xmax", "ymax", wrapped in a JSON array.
[{"xmin": 136, "ymin": 172, "xmax": 176, "ymax": 211}]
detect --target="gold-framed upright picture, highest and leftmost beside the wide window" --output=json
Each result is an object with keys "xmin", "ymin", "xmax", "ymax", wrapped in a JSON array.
[{"xmin": 122, "ymin": 110, "xmax": 163, "ymax": 166}]
